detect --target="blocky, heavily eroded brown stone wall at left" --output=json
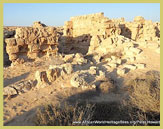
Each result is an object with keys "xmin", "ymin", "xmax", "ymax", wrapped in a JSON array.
[{"xmin": 5, "ymin": 23, "xmax": 58, "ymax": 63}]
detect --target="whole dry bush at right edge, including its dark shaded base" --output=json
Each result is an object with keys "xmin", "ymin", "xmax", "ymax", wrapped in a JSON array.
[{"xmin": 123, "ymin": 71, "xmax": 160, "ymax": 125}]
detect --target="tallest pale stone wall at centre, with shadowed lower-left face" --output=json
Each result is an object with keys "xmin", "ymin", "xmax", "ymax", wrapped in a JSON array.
[{"xmin": 61, "ymin": 13, "xmax": 120, "ymax": 54}]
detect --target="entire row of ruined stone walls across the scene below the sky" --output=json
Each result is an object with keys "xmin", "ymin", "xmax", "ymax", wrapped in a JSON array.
[{"xmin": 4, "ymin": 13, "xmax": 160, "ymax": 66}]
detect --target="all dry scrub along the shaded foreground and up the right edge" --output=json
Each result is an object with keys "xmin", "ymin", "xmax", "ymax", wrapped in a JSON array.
[{"xmin": 35, "ymin": 72, "xmax": 160, "ymax": 126}]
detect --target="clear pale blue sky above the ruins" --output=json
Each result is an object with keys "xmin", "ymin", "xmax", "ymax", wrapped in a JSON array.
[{"xmin": 3, "ymin": 3, "xmax": 160, "ymax": 26}]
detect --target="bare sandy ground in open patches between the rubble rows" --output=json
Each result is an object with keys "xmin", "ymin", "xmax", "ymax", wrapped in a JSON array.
[{"xmin": 4, "ymin": 42, "xmax": 160, "ymax": 126}]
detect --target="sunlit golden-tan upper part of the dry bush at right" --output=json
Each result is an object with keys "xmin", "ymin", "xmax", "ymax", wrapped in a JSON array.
[{"xmin": 128, "ymin": 72, "xmax": 160, "ymax": 113}]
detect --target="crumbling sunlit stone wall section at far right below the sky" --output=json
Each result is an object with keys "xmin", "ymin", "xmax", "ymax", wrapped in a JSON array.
[{"xmin": 118, "ymin": 16, "xmax": 160, "ymax": 41}]
